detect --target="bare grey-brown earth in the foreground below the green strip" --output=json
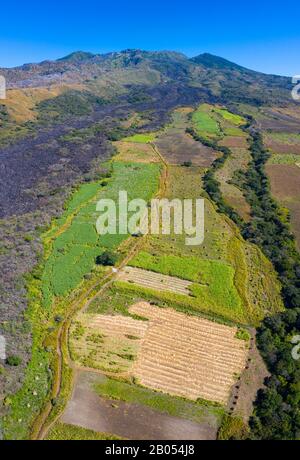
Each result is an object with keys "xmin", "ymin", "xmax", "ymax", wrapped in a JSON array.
[{"xmin": 61, "ymin": 371, "xmax": 217, "ymax": 440}]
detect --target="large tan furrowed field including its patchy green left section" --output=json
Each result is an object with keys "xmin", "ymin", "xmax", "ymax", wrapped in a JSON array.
[{"xmin": 70, "ymin": 302, "xmax": 247, "ymax": 405}]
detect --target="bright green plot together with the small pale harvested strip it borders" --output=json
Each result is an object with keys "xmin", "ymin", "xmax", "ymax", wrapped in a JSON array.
[{"xmin": 121, "ymin": 252, "xmax": 245, "ymax": 322}]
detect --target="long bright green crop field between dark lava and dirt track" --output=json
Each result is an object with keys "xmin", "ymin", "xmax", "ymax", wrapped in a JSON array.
[{"xmin": 43, "ymin": 162, "xmax": 160, "ymax": 307}]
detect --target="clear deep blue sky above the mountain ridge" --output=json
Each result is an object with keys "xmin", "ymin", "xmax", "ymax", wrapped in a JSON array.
[{"xmin": 0, "ymin": 0, "xmax": 300, "ymax": 75}]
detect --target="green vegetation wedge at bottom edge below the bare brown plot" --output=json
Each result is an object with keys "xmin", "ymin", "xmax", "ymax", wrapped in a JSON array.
[{"xmin": 46, "ymin": 422, "xmax": 122, "ymax": 441}]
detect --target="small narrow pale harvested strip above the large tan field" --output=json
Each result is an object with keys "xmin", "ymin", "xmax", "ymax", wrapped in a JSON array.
[{"xmin": 118, "ymin": 266, "xmax": 192, "ymax": 295}]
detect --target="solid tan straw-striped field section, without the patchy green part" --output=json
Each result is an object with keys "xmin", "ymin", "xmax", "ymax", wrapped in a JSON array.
[{"xmin": 129, "ymin": 302, "xmax": 247, "ymax": 404}]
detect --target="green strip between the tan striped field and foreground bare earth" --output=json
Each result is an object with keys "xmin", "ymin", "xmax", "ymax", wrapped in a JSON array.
[{"xmin": 95, "ymin": 378, "xmax": 224, "ymax": 423}]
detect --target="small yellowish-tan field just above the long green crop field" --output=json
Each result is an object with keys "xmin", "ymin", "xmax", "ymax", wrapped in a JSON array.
[{"xmin": 114, "ymin": 141, "xmax": 159, "ymax": 163}]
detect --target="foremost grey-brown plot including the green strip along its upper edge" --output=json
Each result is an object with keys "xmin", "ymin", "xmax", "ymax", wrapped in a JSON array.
[{"xmin": 61, "ymin": 371, "xmax": 220, "ymax": 440}]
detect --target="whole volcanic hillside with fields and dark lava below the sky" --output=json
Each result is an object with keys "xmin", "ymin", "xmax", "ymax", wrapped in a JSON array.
[{"xmin": 0, "ymin": 50, "xmax": 300, "ymax": 439}]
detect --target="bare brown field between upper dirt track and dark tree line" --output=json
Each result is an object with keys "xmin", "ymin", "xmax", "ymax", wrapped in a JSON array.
[{"xmin": 155, "ymin": 130, "xmax": 219, "ymax": 167}]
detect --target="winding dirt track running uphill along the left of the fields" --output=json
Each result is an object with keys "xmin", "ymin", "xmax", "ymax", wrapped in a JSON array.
[{"xmin": 34, "ymin": 143, "xmax": 168, "ymax": 440}]
